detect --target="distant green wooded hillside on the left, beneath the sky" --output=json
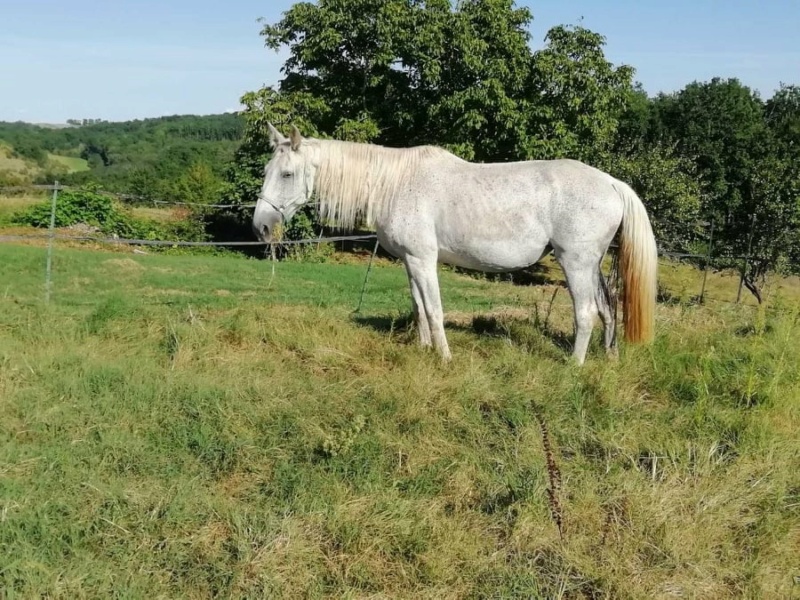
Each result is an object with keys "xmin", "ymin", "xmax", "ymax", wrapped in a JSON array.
[{"xmin": 0, "ymin": 113, "xmax": 244, "ymax": 196}]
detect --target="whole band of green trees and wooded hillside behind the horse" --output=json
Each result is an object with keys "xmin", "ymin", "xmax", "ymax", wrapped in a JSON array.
[{"xmin": 0, "ymin": 0, "xmax": 800, "ymax": 288}]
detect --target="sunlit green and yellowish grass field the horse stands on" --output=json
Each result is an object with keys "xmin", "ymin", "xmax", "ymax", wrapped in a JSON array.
[{"xmin": 0, "ymin": 244, "xmax": 800, "ymax": 598}]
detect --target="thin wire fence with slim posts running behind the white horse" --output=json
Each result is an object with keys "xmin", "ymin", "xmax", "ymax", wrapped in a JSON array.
[{"xmin": 0, "ymin": 181, "xmax": 750, "ymax": 306}]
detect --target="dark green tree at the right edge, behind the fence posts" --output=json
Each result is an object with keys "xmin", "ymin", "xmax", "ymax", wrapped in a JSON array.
[{"xmin": 654, "ymin": 78, "xmax": 798, "ymax": 298}]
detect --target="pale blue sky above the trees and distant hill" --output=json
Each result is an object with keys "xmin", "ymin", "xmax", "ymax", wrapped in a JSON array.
[{"xmin": 0, "ymin": 0, "xmax": 800, "ymax": 122}]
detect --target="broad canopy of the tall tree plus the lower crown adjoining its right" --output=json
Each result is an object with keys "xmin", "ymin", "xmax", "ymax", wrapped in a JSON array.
[{"xmin": 253, "ymin": 0, "xmax": 633, "ymax": 161}]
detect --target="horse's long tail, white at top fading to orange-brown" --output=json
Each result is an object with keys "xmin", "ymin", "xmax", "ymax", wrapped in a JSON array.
[{"xmin": 614, "ymin": 180, "xmax": 658, "ymax": 342}]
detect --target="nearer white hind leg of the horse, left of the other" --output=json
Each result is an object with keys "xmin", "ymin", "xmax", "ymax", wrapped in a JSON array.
[{"xmin": 556, "ymin": 252, "xmax": 598, "ymax": 365}]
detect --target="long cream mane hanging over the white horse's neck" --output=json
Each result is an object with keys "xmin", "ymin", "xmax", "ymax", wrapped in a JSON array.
[{"xmin": 305, "ymin": 139, "xmax": 449, "ymax": 230}]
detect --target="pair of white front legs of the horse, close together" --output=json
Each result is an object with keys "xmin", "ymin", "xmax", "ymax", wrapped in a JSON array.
[{"xmin": 404, "ymin": 255, "xmax": 452, "ymax": 360}]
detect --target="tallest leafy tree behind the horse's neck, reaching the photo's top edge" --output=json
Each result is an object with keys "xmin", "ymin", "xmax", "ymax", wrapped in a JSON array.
[{"xmin": 262, "ymin": 0, "xmax": 531, "ymax": 159}]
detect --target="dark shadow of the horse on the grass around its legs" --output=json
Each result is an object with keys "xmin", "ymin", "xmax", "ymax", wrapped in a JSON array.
[{"xmin": 352, "ymin": 312, "xmax": 572, "ymax": 353}]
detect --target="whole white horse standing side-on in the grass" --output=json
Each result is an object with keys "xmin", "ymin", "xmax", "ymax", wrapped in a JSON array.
[{"xmin": 253, "ymin": 124, "xmax": 658, "ymax": 364}]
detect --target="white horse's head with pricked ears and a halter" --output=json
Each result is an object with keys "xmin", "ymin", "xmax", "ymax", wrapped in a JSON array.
[{"xmin": 253, "ymin": 124, "xmax": 315, "ymax": 242}]
